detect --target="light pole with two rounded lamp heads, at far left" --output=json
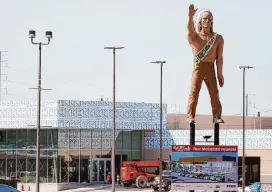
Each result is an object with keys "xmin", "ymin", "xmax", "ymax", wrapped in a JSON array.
[{"xmin": 29, "ymin": 30, "xmax": 52, "ymax": 192}]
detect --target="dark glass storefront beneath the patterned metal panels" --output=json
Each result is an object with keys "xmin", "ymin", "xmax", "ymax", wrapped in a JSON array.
[{"xmin": 0, "ymin": 128, "xmax": 142, "ymax": 183}]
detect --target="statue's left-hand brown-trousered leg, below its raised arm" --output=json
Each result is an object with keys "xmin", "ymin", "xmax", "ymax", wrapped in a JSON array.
[{"xmin": 187, "ymin": 65, "xmax": 203, "ymax": 123}]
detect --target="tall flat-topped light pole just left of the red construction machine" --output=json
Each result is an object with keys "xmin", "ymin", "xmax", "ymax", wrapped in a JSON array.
[{"xmin": 104, "ymin": 47, "xmax": 124, "ymax": 192}]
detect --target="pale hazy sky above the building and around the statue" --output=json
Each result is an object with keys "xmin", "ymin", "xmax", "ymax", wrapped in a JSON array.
[{"xmin": 0, "ymin": 0, "xmax": 272, "ymax": 115}]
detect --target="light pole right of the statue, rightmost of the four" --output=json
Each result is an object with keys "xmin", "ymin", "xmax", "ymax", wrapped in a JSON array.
[{"xmin": 239, "ymin": 66, "xmax": 253, "ymax": 192}]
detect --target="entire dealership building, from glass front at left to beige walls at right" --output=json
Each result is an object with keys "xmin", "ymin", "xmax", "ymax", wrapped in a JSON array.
[{"xmin": 0, "ymin": 100, "xmax": 272, "ymax": 189}]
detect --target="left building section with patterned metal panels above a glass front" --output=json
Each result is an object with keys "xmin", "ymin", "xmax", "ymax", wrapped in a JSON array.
[{"xmin": 0, "ymin": 100, "xmax": 166, "ymax": 183}]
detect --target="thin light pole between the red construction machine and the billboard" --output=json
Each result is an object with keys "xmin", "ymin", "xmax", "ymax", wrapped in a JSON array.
[{"xmin": 151, "ymin": 61, "xmax": 166, "ymax": 191}]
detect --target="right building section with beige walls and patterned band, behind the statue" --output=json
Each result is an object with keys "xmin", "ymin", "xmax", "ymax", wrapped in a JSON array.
[{"xmin": 144, "ymin": 113, "xmax": 272, "ymax": 186}]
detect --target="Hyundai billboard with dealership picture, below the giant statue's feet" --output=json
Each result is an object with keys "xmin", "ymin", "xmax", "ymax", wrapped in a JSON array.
[{"xmin": 172, "ymin": 145, "xmax": 238, "ymax": 191}]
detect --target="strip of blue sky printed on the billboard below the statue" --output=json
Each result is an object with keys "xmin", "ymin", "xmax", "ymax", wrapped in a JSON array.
[{"xmin": 172, "ymin": 152, "xmax": 238, "ymax": 161}]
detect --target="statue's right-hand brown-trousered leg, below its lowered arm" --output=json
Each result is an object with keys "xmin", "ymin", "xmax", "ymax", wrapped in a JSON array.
[{"xmin": 204, "ymin": 63, "xmax": 224, "ymax": 123}]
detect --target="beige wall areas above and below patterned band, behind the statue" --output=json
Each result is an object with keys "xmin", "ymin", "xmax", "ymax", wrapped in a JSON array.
[{"xmin": 143, "ymin": 114, "xmax": 272, "ymax": 183}]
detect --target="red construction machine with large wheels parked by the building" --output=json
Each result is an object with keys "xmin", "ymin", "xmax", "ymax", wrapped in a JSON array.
[{"xmin": 120, "ymin": 161, "xmax": 160, "ymax": 188}]
